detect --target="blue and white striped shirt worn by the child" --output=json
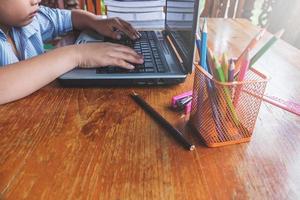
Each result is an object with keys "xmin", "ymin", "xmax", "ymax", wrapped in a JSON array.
[{"xmin": 0, "ymin": 6, "xmax": 73, "ymax": 67}]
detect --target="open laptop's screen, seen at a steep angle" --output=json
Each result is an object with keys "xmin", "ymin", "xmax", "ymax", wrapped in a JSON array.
[{"xmin": 166, "ymin": 0, "xmax": 199, "ymax": 71}]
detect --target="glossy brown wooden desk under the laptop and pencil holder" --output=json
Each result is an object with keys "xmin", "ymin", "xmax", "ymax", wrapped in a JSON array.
[{"xmin": 0, "ymin": 19, "xmax": 300, "ymax": 199}]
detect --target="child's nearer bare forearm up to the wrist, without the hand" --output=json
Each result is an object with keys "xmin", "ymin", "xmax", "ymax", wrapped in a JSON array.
[{"xmin": 0, "ymin": 46, "xmax": 79, "ymax": 104}]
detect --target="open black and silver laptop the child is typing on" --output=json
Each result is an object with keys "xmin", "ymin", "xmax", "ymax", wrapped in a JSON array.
[{"xmin": 59, "ymin": 0, "xmax": 200, "ymax": 87}]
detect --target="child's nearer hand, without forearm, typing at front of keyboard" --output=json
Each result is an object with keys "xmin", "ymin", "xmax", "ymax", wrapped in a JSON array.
[{"xmin": 75, "ymin": 42, "xmax": 144, "ymax": 69}]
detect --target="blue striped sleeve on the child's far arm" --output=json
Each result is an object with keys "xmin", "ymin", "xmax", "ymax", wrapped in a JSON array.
[{"xmin": 37, "ymin": 6, "xmax": 73, "ymax": 41}]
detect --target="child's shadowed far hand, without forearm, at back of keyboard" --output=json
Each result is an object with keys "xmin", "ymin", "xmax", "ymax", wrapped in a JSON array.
[{"xmin": 93, "ymin": 17, "xmax": 141, "ymax": 40}]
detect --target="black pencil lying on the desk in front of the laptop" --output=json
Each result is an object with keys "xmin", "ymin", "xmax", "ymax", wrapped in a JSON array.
[{"xmin": 131, "ymin": 92, "xmax": 195, "ymax": 151}]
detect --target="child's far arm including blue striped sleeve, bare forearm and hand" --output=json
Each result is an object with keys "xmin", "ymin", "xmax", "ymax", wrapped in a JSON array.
[{"xmin": 38, "ymin": 6, "xmax": 140, "ymax": 41}]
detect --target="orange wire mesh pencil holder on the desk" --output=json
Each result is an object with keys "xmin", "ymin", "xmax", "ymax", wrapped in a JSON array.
[{"xmin": 189, "ymin": 65, "xmax": 268, "ymax": 147}]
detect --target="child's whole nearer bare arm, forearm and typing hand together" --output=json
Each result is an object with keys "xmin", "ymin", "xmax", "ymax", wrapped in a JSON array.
[{"xmin": 0, "ymin": 43, "xmax": 143, "ymax": 105}]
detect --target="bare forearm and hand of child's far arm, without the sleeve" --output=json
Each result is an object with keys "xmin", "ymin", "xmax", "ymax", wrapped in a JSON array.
[{"xmin": 72, "ymin": 10, "xmax": 140, "ymax": 40}]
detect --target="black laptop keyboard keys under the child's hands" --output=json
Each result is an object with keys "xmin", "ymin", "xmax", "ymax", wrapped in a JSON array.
[{"xmin": 96, "ymin": 31, "xmax": 167, "ymax": 74}]
